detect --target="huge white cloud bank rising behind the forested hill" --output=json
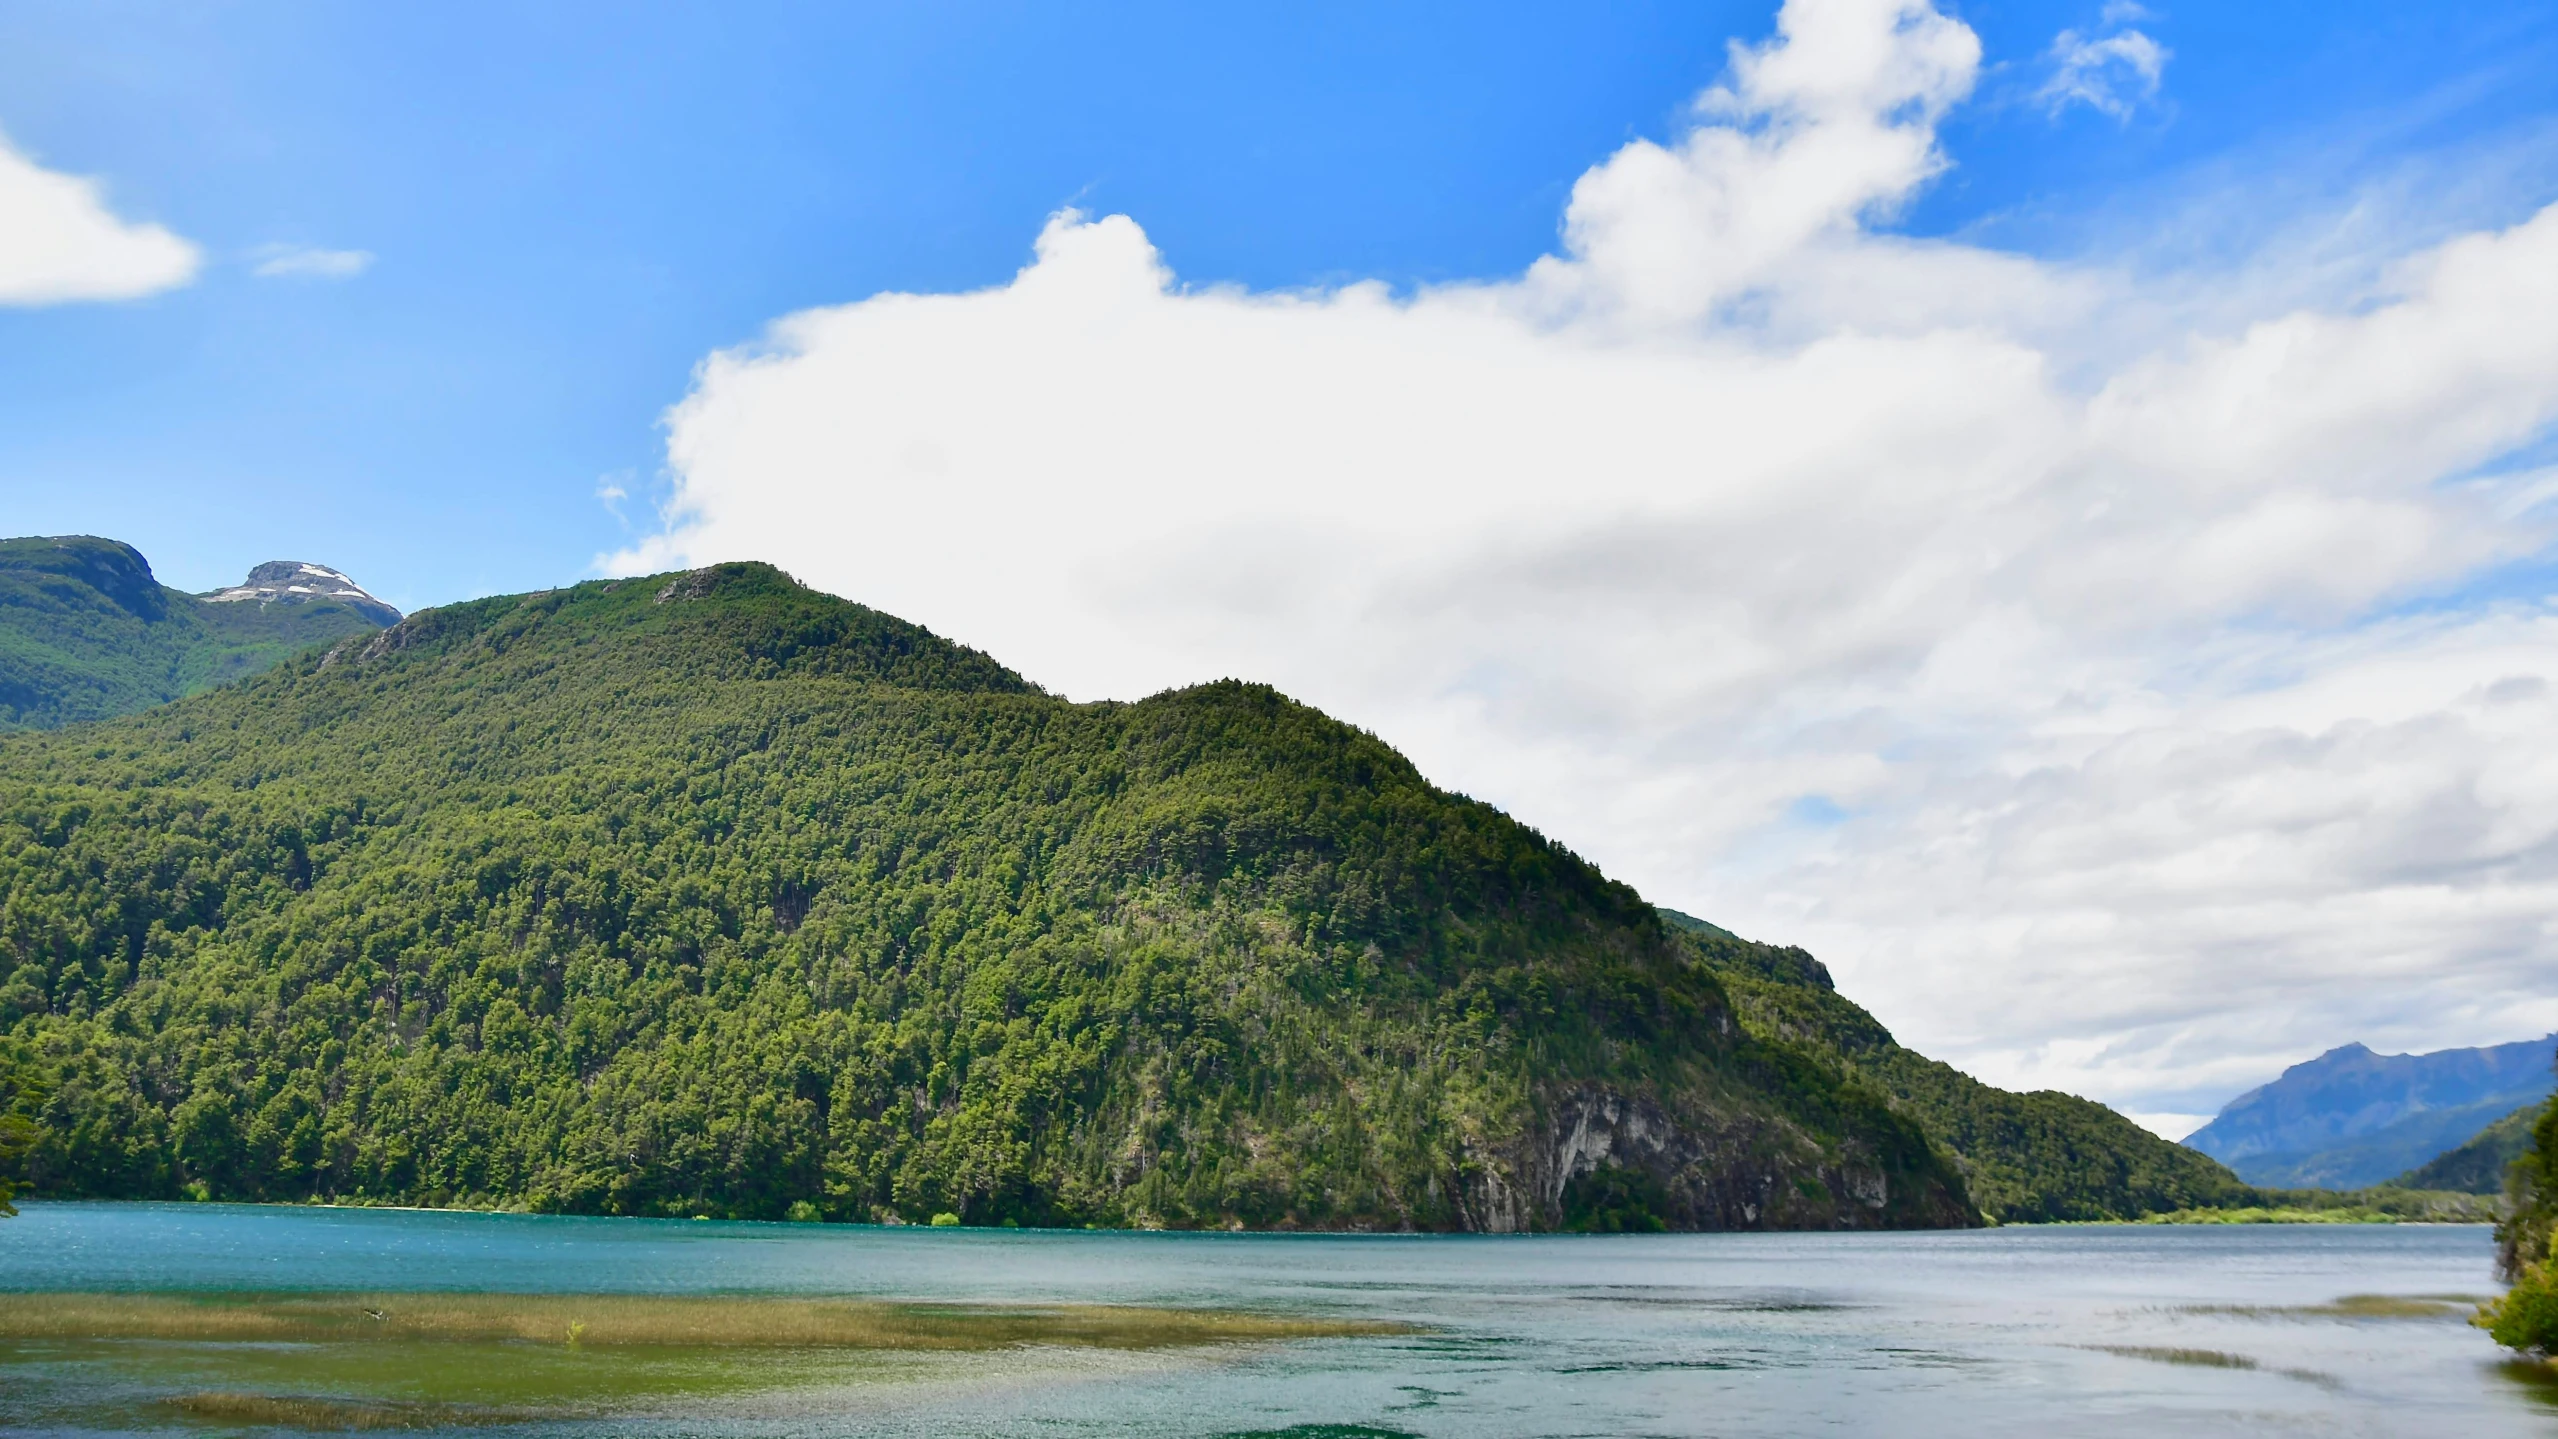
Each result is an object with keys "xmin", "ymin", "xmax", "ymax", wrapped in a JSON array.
[{"xmin": 606, "ymin": 0, "xmax": 2558, "ymax": 1112}]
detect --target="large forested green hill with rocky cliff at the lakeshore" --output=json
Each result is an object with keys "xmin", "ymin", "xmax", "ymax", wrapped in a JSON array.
[{"xmin": 0, "ymin": 565, "xmax": 1977, "ymax": 1229}]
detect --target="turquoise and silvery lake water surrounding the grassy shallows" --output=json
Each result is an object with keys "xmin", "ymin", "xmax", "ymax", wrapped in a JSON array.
[{"xmin": 0, "ymin": 1204, "xmax": 2558, "ymax": 1439}]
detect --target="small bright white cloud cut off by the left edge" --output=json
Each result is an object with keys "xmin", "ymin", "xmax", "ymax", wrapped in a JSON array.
[{"xmin": 0, "ymin": 141, "xmax": 197, "ymax": 304}]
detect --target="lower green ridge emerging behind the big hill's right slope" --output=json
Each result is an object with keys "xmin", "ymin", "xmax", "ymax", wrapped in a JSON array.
[{"xmin": 1665, "ymin": 910, "xmax": 2254, "ymax": 1222}]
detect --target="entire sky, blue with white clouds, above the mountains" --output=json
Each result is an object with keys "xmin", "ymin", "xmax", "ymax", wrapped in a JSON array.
[{"xmin": 0, "ymin": 0, "xmax": 2558, "ymax": 1114}]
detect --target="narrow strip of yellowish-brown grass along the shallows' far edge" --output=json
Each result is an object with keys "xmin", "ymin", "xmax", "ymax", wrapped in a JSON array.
[{"xmin": 0, "ymin": 1293, "xmax": 1409, "ymax": 1350}]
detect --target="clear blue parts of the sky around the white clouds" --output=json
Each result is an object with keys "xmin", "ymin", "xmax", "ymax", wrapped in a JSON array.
[{"xmin": 0, "ymin": 0, "xmax": 2558, "ymax": 606}]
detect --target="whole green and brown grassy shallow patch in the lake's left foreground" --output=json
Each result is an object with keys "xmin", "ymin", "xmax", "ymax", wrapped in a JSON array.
[{"xmin": 0, "ymin": 1291, "xmax": 1412, "ymax": 1431}]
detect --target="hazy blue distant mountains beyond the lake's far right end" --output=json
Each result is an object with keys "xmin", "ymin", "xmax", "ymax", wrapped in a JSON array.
[{"xmin": 2185, "ymin": 1035, "xmax": 2558, "ymax": 1191}]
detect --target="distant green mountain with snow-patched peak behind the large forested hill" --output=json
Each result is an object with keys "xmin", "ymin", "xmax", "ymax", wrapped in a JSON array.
[{"xmin": 0, "ymin": 534, "xmax": 399, "ymax": 731}]
